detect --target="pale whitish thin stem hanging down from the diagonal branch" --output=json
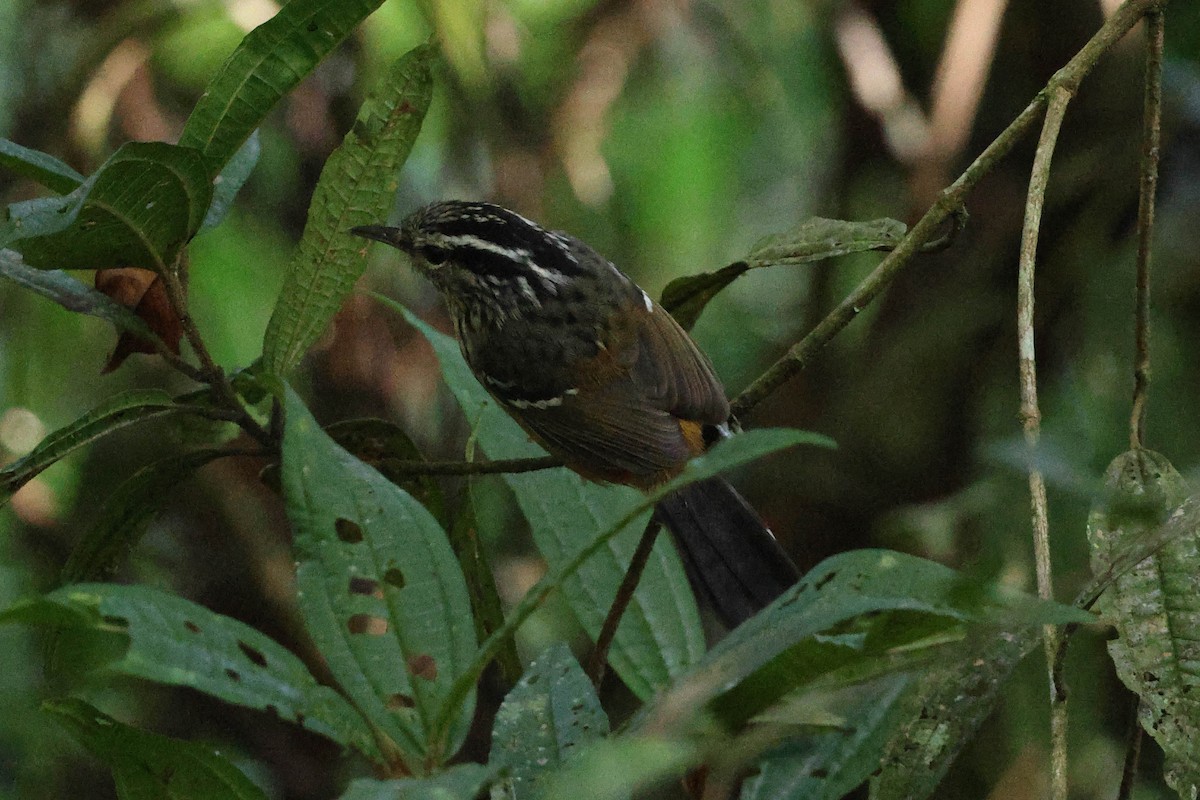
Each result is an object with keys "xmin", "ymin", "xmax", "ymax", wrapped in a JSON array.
[{"xmin": 1016, "ymin": 86, "xmax": 1073, "ymax": 800}]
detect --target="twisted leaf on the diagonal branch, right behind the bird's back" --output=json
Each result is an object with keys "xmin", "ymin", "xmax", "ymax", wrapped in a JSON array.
[{"xmin": 662, "ymin": 217, "xmax": 907, "ymax": 330}]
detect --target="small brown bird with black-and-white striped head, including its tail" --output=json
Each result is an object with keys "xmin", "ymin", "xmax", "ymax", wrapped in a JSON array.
[{"xmin": 350, "ymin": 200, "xmax": 799, "ymax": 628}]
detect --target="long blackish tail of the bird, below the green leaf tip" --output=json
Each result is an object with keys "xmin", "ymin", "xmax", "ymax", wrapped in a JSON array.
[{"xmin": 656, "ymin": 477, "xmax": 800, "ymax": 627}]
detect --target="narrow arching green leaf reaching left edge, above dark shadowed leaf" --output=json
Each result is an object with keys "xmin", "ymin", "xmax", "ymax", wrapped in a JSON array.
[{"xmin": 0, "ymin": 388, "xmax": 180, "ymax": 506}]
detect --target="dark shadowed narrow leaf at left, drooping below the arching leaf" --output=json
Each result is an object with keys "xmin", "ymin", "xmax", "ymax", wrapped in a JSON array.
[{"xmin": 62, "ymin": 450, "xmax": 226, "ymax": 583}]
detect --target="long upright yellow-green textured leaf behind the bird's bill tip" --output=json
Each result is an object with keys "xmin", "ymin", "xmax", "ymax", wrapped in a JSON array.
[{"xmin": 263, "ymin": 46, "xmax": 434, "ymax": 377}]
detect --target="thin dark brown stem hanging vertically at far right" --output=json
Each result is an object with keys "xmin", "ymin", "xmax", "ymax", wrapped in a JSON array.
[{"xmin": 1129, "ymin": 10, "xmax": 1164, "ymax": 447}]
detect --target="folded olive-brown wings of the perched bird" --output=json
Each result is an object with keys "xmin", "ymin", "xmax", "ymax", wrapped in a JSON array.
[{"xmin": 499, "ymin": 298, "xmax": 728, "ymax": 487}]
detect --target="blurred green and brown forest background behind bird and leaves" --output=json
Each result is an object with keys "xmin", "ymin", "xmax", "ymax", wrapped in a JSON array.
[{"xmin": 0, "ymin": 0, "xmax": 1200, "ymax": 800}]
